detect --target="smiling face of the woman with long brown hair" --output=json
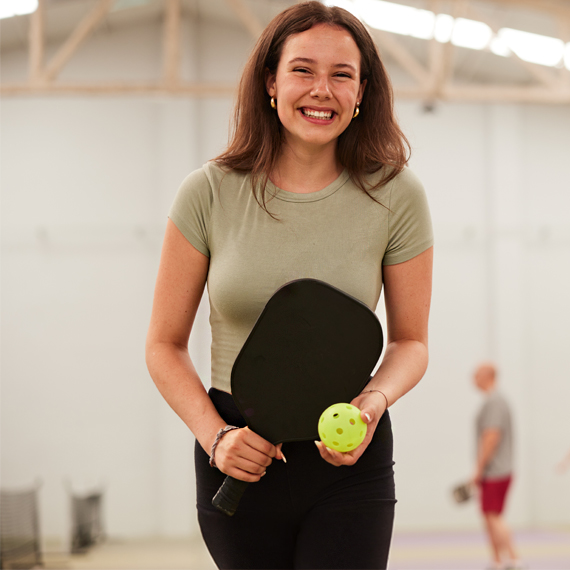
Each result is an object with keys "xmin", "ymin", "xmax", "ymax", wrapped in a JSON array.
[{"xmin": 266, "ymin": 24, "xmax": 366, "ymax": 153}]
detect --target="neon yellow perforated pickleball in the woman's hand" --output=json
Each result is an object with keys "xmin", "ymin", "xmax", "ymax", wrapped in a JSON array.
[{"xmin": 319, "ymin": 403, "xmax": 368, "ymax": 453}]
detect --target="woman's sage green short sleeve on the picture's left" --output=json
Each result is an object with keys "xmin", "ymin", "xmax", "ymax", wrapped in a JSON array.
[{"xmin": 168, "ymin": 168, "xmax": 212, "ymax": 257}]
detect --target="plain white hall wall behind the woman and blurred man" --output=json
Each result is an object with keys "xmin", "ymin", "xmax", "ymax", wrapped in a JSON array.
[{"xmin": 1, "ymin": 10, "xmax": 570, "ymax": 536}]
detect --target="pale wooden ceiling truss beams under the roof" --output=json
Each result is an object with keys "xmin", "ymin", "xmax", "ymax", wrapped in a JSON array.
[{"xmin": 0, "ymin": 0, "xmax": 570, "ymax": 105}]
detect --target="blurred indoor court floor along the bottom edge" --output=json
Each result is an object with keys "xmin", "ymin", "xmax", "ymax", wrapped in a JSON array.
[{"xmin": 40, "ymin": 529, "xmax": 570, "ymax": 570}]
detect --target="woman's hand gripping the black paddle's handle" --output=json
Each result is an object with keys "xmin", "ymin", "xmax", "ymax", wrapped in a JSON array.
[{"xmin": 215, "ymin": 427, "xmax": 283, "ymax": 483}]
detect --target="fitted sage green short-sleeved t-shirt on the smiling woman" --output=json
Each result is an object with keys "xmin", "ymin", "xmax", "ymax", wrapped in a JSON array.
[{"xmin": 169, "ymin": 162, "xmax": 433, "ymax": 392}]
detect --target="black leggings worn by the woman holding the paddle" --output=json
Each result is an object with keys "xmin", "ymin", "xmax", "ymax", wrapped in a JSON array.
[{"xmin": 194, "ymin": 389, "xmax": 396, "ymax": 570}]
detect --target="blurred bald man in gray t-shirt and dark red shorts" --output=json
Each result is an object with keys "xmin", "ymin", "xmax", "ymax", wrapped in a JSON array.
[{"xmin": 472, "ymin": 363, "xmax": 521, "ymax": 570}]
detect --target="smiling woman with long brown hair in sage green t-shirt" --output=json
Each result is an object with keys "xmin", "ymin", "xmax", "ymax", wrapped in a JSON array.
[{"xmin": 147, "ymin": 2, "xmax": 433, "ymax": 570}]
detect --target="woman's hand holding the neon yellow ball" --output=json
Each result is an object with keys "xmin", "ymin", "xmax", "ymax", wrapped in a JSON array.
[{"xmin": 315, "ymin": 392, "xmax": 386, "ymax": 467}]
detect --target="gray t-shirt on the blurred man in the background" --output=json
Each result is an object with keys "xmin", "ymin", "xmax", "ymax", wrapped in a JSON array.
[{"xmin": 476, "ymin": 390, "xmax": 513, "ymax": 479}]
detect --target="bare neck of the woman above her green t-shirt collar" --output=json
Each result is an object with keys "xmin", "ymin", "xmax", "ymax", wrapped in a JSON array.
[{"xmin": 269, "ymin": 143, "xmax": 343, "ymax": 194}]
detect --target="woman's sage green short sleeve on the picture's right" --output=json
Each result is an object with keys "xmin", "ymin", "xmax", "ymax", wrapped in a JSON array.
[{"xmin": 382, "ymin": 168, "xmax": 433, "ymax": 265}]
